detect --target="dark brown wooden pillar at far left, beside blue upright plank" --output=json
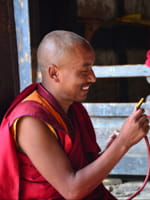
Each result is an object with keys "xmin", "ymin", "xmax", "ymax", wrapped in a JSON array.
[{"xmin": 0, "ymin": 0, "xmax": 19, "ymax": 120}]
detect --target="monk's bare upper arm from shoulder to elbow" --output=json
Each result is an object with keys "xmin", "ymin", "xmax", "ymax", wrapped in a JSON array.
[{"xmin": 17, "ymin": 116, "xmax": 72, "ymax": 195}]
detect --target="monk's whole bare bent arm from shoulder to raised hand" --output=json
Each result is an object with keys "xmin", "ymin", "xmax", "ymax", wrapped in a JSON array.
[{"xmin": 17, "ymin": 109, "xmax": 149, "ymax": 200}]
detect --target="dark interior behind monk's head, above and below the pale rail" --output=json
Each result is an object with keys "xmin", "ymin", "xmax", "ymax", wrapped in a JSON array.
[{"xmin": 29, "ymin": 0, "xmax": 150, "ymax": 102}]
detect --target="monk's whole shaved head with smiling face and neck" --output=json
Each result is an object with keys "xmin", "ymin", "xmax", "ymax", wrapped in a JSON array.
[{"xmin": 37, "ymin": 31, "xmax": 96, "ymax": 112}]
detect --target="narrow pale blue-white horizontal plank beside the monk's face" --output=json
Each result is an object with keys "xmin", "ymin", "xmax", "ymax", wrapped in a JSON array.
[{"xmin": 93, "ymin": 65, "xmax": 150, "ymax": 78}]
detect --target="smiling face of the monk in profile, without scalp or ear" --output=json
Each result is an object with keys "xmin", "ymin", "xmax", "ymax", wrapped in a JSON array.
[{"xmin": 56, "ymin": 46, "xmax": 96, "ymax": 104}]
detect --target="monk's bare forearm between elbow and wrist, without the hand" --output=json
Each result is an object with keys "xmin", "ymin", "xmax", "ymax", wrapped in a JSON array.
[{"xmin": 69, "ymin": 134, "xmax": 128, "ymax": 196}]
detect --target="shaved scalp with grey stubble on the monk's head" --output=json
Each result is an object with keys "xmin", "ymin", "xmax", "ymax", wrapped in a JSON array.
[{"xmin": 37, "ymin": 30, "xmax": 92, "ymax": 73}]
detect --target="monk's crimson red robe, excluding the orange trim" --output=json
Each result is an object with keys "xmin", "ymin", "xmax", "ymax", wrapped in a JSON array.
[{"xmin": 0, "ymin": 84, "xmax": 116, "ymax": 200}]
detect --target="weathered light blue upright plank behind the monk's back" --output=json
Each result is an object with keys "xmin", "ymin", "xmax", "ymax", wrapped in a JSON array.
[{"xmin": 14, "ymin": 0, "xmax": 32, "ymax": 90}]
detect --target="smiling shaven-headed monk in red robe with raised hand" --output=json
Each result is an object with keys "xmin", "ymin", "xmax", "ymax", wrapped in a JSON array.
[{"xmin": 0, "ymin": 30, "xmax": 149, "ymax": 200}]
